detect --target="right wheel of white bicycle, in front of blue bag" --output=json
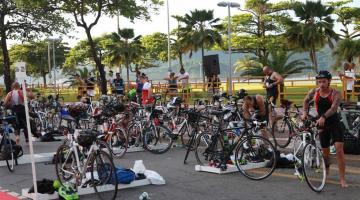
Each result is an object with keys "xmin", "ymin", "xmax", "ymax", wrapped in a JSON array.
[{"xmin": 90, "ymin": 150, "xmax": 118, "ymax": 200}]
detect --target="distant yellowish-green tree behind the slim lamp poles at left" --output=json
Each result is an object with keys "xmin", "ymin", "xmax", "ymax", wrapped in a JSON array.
[{"xmin": 10, "ymin": 41, "xmax": 68, "ymax": 85}]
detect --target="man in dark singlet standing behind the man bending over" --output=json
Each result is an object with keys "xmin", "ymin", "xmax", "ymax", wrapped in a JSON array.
[{"xmin": 263, "ymin": 66, "xmax": 284, "ymax": 104}]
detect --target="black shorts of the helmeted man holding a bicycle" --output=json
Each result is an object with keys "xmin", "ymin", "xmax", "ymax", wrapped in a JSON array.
[{"xmin": 319, "ymin": 117, "xmax": 344, "ymax": 148}]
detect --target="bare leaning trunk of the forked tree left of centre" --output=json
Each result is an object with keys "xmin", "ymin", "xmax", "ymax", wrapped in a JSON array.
[{"xmin": 85, "ymin": 28, "xmax": 107, "ymax": 95}]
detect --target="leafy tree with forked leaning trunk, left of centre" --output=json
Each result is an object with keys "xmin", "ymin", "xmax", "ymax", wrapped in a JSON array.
[{"xmin": 59, "ymin": 0, "xmax": 162, "ymax": 94}]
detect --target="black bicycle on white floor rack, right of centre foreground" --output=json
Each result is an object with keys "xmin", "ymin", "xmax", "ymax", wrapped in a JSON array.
[{"xmin": 190, "ymin": 105, "xmax": 276, "ymax": 180}]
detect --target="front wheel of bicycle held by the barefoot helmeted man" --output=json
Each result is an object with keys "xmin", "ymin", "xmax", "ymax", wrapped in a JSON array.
[{"xmin": 302, "ymin": 144, "xmax": 326, "ymax": 192}]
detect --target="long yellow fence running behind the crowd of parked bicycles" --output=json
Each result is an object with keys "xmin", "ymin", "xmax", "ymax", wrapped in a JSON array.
[{"xmin": 0, "ymin": 77, "xmax": 354, "ymax": 103}]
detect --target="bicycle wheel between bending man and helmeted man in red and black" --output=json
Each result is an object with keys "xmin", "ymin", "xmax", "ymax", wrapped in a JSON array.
[{"xmin": 271, "ymin": 119, "xmax": 293, "ymax": 148}]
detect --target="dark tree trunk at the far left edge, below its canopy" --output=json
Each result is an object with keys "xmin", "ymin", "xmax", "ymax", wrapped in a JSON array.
[{"xmin": 0, "ymin": 15, "xmax": 12, "ymax": 92}]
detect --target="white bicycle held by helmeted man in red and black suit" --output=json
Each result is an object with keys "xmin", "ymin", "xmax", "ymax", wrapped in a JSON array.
[{"xmin": 293, "ymin": 118, "xmax": 326, "ymax": 192}]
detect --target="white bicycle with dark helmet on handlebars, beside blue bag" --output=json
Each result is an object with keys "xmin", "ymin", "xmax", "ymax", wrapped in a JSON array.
[{"xmin": 55, "ymin": 130, "xmax": 118, "ymax": 200}]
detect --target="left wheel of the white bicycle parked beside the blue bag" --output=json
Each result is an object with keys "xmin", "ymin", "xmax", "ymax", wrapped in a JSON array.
[{"xmin": 55, "ymin": 145, "xmax": 76, "ymax": 184}]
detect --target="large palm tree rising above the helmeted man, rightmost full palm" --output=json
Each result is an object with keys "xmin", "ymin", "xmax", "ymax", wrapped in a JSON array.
[{"xmin": 285, "ymin": 1, "xmax": 338, "ymax": 72}]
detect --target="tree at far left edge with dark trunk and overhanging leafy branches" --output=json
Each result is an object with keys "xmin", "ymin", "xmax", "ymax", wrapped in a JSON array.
[{"xmin": 0, "ymin": 0, "xmax": 70, "ymax": 92}]
